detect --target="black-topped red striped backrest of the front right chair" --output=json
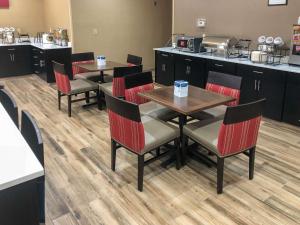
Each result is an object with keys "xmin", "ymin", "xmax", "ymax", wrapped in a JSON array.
[{"xmin": 218, "ymin": 99, "xmax": 266, "ymax": 156}]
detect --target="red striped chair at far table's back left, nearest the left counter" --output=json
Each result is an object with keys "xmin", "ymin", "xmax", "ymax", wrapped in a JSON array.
[{"xmin": 72, "ymin": 52, "xmax": 101, "ymax": 82}]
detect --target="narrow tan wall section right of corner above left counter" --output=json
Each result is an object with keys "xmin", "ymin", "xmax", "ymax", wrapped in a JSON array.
[{"xmin": 43, "ymin": 0, "xmax": 72, "ymax": 39}]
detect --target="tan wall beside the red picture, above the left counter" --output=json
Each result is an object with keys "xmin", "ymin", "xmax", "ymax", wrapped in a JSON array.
[{"xmin": 0, "ymin": 0, "xmax": 44, "ymax": 35}]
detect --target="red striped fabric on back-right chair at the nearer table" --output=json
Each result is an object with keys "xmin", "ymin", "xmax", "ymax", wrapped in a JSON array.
[{"xmin": 206, "ymin": 83, "xmax": 241, "ymax": 106}]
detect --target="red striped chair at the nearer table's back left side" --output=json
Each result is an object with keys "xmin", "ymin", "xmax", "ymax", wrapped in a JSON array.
[{"xmin": 125, "ymin": 72, "xmax": 179, "ymax": 121}]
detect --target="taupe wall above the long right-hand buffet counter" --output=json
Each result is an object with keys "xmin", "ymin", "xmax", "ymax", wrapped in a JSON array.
[{"xmin": 174, "ymin": 0, "xmax": 300, "ymax": 45}]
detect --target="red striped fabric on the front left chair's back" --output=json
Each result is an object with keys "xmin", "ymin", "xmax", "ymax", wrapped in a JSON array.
[{"xmin": 108, "ymin": 110, "xmax": 145, "ymax": 154}]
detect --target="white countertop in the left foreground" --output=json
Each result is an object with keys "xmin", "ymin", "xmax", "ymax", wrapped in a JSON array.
[{"xmin": 0, "ymin": 103, "xmax": 44, "ymax": 191}]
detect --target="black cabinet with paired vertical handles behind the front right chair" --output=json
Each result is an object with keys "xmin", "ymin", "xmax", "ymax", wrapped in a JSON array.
[{"xmin": 237, "ymin": 65, "xmax": 286, "ymax": 121}]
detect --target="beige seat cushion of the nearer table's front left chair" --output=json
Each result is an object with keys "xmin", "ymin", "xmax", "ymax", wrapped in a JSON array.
[{"xmin": 141, "ymin": 116, "xmax": 180, "ymax": 154}]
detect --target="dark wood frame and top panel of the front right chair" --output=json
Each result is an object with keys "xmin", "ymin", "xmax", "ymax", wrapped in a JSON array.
[{"xmin": 182, "ymin": 99, "xmax": 266, "ymax": 194}]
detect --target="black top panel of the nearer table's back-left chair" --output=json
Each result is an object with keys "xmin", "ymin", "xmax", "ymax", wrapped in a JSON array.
[{"xmin": 125, "ymin": 72, "xmax": 153, "ymax": 89}]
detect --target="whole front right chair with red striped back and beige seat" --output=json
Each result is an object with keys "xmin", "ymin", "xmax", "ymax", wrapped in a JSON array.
[{"xmin": 183, "ymin": 99, "xmax": 266, "ymax": 194}]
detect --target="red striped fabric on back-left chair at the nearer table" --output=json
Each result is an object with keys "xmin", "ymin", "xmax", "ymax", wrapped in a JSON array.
[{"xmin": 125, "ymin": 83, "xmax": 154, "ymax": 105}]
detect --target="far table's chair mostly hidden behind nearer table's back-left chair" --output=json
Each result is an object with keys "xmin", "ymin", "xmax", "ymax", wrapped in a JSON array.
[{"xmin": 99, "ymin": 65, "xmax": 143, "ymax": 98}]
